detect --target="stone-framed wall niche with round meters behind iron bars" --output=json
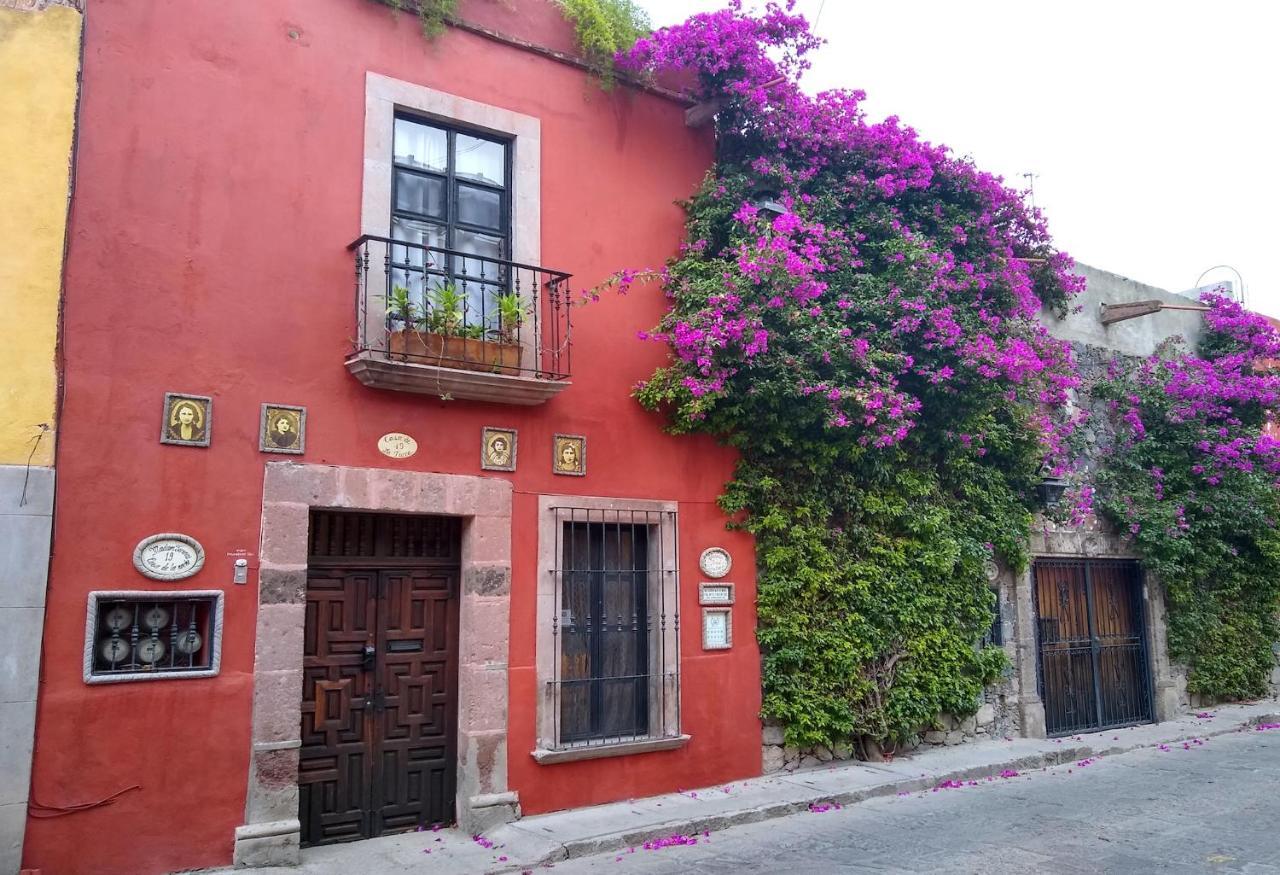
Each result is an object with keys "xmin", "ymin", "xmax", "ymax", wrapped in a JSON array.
[{"xmin": 84, "ymin": 591, "xmax": 223, "ymax": 683}]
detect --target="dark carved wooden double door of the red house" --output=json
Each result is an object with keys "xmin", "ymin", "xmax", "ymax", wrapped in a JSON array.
[{"xmin": 298, "ymin": 563, "xmax": 458, "ymax": 846}]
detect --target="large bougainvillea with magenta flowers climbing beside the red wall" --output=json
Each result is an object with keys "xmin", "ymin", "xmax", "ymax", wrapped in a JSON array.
[{"xmin": 620, "ymin": 3, "xmax": 1080, "ymax": 753}]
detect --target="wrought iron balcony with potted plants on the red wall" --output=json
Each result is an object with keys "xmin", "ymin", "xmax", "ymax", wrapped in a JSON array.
[{"xmin": 347, "ymin": 234, "xmax": 571, "ymax": 404}]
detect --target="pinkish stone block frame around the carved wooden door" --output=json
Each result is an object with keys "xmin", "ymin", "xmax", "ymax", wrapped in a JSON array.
[{"xmin": 234, "ymin": 462, "xmax": 520, "ymax": 866}]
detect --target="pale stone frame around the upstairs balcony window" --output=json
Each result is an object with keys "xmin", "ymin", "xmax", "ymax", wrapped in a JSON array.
[{"xmin": 360, "ymin": 73, "xmax": 543, "ymax": 368}]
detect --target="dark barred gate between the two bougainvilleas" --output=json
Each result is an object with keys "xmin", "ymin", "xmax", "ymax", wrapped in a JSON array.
[{"xmin": 1033, "ymin": 559, "xmax": 1152, "ymax": 736}]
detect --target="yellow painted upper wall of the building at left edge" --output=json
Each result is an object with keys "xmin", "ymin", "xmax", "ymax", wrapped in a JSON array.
[{"xmin": 0, "ymin": 0, "xmax": 81, "ymax": 466}]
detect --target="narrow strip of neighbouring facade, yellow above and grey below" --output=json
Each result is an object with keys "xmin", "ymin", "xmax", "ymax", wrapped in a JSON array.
[{"xmin": 0, "ymin": 0, "xmax": 81, "ymax": 872}]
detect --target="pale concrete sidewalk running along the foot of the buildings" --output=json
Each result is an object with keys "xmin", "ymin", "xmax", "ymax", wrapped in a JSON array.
[{"xmin": 209, "ymin": 701, "xmax": 1280, "ymax": 875}]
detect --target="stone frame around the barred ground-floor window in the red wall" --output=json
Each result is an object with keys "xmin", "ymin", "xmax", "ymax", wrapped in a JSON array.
[{"xmin": 531, "ymin": 495, "xmax": 690, "ymax": 765}]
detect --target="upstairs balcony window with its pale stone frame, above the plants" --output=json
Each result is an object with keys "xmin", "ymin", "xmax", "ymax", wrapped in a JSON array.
[{"xmin": 360, "ymin": 73, "xmax": 545, "ymax": 367}]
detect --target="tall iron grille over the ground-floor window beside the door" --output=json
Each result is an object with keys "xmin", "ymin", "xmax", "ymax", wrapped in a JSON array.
[{"xmin": 548, "ymin": 507, "xmax": 680, "ymax": 748}]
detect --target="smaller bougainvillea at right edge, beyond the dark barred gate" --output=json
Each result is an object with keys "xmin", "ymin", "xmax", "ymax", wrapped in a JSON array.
[{"xmin": 1093, "ymin": 293, "xmax": 1280, "ymax": 698}]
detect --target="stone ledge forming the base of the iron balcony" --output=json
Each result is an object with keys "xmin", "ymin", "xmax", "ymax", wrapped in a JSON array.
[{"xmin": 347, "ymin": 351, "xmax": 571, "ymax": 407}]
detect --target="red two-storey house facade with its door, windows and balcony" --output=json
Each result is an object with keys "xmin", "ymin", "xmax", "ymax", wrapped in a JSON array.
[{"xmin": 22, "ymin": 0, "xmax": 760, "ymax": 875}]
